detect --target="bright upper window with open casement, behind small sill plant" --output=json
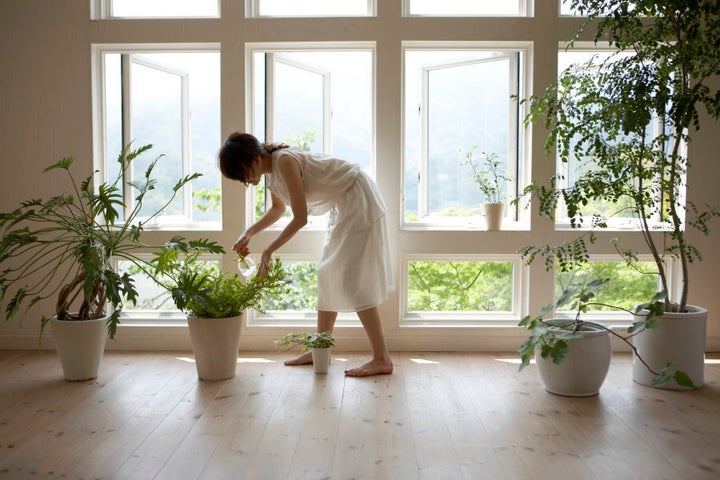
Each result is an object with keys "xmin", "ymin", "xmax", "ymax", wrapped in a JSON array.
[{"xmin": 404, "ymin": 46, "xmax": 525, "ymax": 229}]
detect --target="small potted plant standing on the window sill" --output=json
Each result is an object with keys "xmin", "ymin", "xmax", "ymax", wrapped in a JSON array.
[{"xmin": 465, "ymin": 146, "xmax": 512, "ymax": 231}]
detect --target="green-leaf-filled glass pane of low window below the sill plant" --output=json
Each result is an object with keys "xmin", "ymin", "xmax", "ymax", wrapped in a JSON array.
[{"xmin": 407, "ymin": 261, "xmax": 513, "ymax": 312}]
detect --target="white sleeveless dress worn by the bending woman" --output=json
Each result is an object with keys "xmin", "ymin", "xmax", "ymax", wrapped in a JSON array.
[{"xmin": 268, "ymin": 147, "xmax": 394, "ymax": 312}]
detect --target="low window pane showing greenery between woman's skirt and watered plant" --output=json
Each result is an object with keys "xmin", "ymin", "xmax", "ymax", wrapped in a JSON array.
[{"xmin": 260, "ymin": 261, "xmax": 317, "ymax": 312}]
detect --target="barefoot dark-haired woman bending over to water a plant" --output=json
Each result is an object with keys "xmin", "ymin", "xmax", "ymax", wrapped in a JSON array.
[{"xmin": 219, "ymin": 133, "xmax": 393, "ymax": 377}]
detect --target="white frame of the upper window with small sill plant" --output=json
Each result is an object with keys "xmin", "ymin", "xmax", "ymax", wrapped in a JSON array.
[{"xmin": 401, "ymin": 41, "xmax": 533, "ymax": 231}]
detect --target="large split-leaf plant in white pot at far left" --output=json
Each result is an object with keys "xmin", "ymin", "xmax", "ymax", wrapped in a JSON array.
[{"xmin": 0, "ymin": 145, "xmax": 199, "ymax": 381}]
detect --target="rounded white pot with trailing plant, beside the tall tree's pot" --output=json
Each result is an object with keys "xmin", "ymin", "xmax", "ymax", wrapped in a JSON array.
[{"xmin": 535, "ymin": 320, "xmax": 612, "ymax": 397}]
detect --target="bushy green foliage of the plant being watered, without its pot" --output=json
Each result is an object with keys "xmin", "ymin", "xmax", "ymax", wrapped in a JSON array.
[{"xmin": 152, "ymin": 236, "xmax": 286, "ymax": 318}]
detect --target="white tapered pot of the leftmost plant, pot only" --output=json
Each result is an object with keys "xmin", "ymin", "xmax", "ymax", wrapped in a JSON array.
[{"xmin": 50, "ymin": 317, "xmax": 107, "ymax": 382}]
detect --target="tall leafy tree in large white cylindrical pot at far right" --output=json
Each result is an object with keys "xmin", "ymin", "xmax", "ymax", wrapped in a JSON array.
[{"xmin": 524, "ymin": 0, "xmax": 720, "ymax": 388}]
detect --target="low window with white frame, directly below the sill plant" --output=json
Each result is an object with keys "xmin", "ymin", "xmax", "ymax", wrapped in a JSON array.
[{"xmin": 403, "ymin": 255, "xmax": 523, "ymax": 325}]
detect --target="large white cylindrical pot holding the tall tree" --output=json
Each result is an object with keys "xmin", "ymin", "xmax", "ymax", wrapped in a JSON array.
[{"xmin": 633, "ymin": 305, "xmax": 707, "ymax": 390}]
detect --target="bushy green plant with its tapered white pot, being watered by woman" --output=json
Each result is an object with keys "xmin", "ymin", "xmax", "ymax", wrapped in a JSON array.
[{"xmin": 152, "ymin": 236, "xmax": 286, "ymax": 380}]
